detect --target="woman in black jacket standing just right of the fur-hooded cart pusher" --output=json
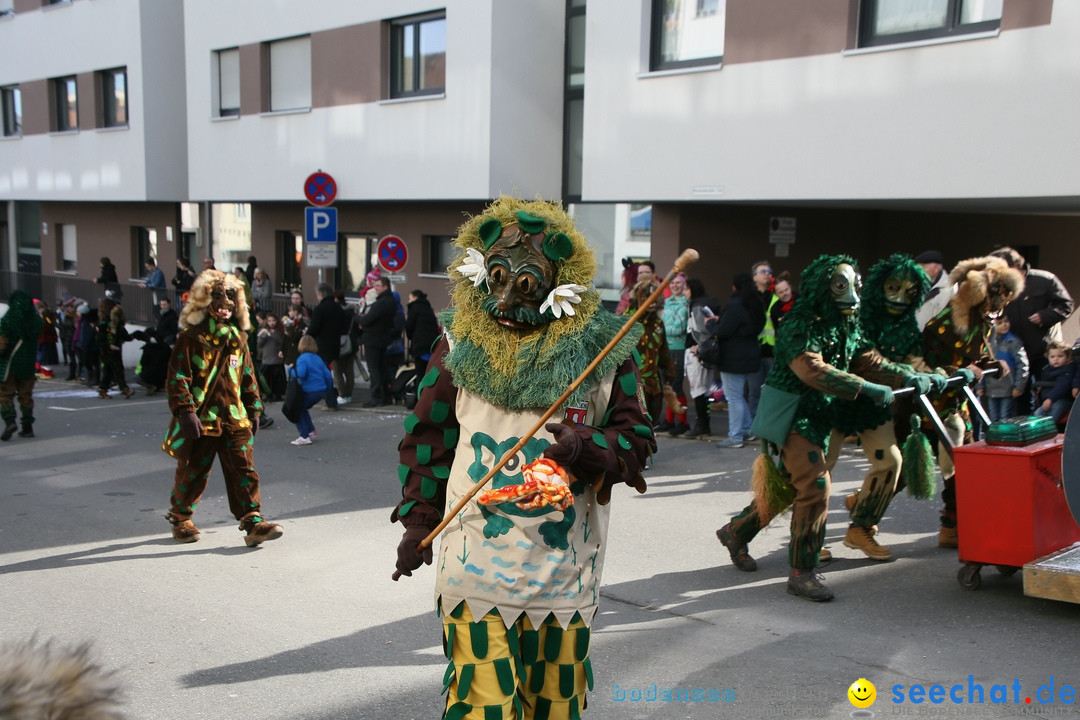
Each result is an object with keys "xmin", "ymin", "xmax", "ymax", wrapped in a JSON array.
[{"xmin": 990, "ymin": 247, "xmax": 1075, "ymax": 415}]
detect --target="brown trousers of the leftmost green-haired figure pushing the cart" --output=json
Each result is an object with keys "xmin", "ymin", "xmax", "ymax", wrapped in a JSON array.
[{"xmin": 731, "ymin": 432, "xmax": 831, "ymax": 570}]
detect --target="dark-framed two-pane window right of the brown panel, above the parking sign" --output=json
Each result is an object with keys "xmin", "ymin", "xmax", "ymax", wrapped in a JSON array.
[{"xmin": 390, "ymin": 12, "xmax": 446, "ymax": 97}]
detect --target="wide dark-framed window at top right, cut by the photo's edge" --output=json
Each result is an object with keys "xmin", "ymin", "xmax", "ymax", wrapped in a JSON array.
[{"xmin": 859, "ymin": 0, "xmax": 1002, "ymax": 46}]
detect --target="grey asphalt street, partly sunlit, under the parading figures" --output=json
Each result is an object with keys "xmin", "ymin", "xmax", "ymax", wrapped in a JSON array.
[{"xmin": 0, "ymin": 381, "xmax": 1080, "ymax": 720}]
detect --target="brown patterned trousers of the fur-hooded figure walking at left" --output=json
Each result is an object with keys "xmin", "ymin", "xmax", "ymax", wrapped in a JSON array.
[{"xmin": 170, "ymin": 427, "xmax": 260, "ymax": 521}]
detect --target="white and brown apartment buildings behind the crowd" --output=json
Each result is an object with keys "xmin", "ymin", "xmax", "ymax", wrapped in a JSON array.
[{"xmin": 0, "ymin": 0, "xmax": 1080, "ymax": 339}]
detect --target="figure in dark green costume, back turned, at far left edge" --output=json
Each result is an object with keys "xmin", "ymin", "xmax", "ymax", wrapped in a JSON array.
[{"xmin": 0, "ymin": 290, "xmax": 41, "ymax": 440}]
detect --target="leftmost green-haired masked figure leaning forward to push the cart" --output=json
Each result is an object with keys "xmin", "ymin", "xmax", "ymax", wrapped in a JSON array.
[{"xmin": 716, "ymin": 255, "xmax": 929, "ymax": 601}]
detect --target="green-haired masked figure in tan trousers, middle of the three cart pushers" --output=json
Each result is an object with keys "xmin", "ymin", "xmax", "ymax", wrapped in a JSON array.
[{"xmin": 822, "ymin": 253, "xmax": 946, "ymax": 561}]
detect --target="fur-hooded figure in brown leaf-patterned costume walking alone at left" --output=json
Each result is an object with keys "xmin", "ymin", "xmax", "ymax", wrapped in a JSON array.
[{"xmin": 161, "ymin": 270, "xmax": 282, "ymax": 545}]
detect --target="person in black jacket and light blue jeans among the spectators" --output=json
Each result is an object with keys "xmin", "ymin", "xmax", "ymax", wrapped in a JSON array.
[{"xmin": 711, "ymin": 272, "xmax": 765, "ymax": 448}]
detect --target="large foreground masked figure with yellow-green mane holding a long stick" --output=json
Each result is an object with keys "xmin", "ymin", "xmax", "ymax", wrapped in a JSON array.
[{"xmin": 391, "ymin": 198, "xmax": 656, "ymax": 720}]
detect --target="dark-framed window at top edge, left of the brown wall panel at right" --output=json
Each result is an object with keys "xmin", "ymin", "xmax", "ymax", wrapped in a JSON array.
[{"xmin": 649, "ymin": 0, "xmax": 727, "ymax": 70}]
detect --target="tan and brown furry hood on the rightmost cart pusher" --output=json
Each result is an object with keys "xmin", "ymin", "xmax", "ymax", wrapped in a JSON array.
[{"xmin": 948, "ymin": 256, "xmax": 1024, "ymax": 335}]
